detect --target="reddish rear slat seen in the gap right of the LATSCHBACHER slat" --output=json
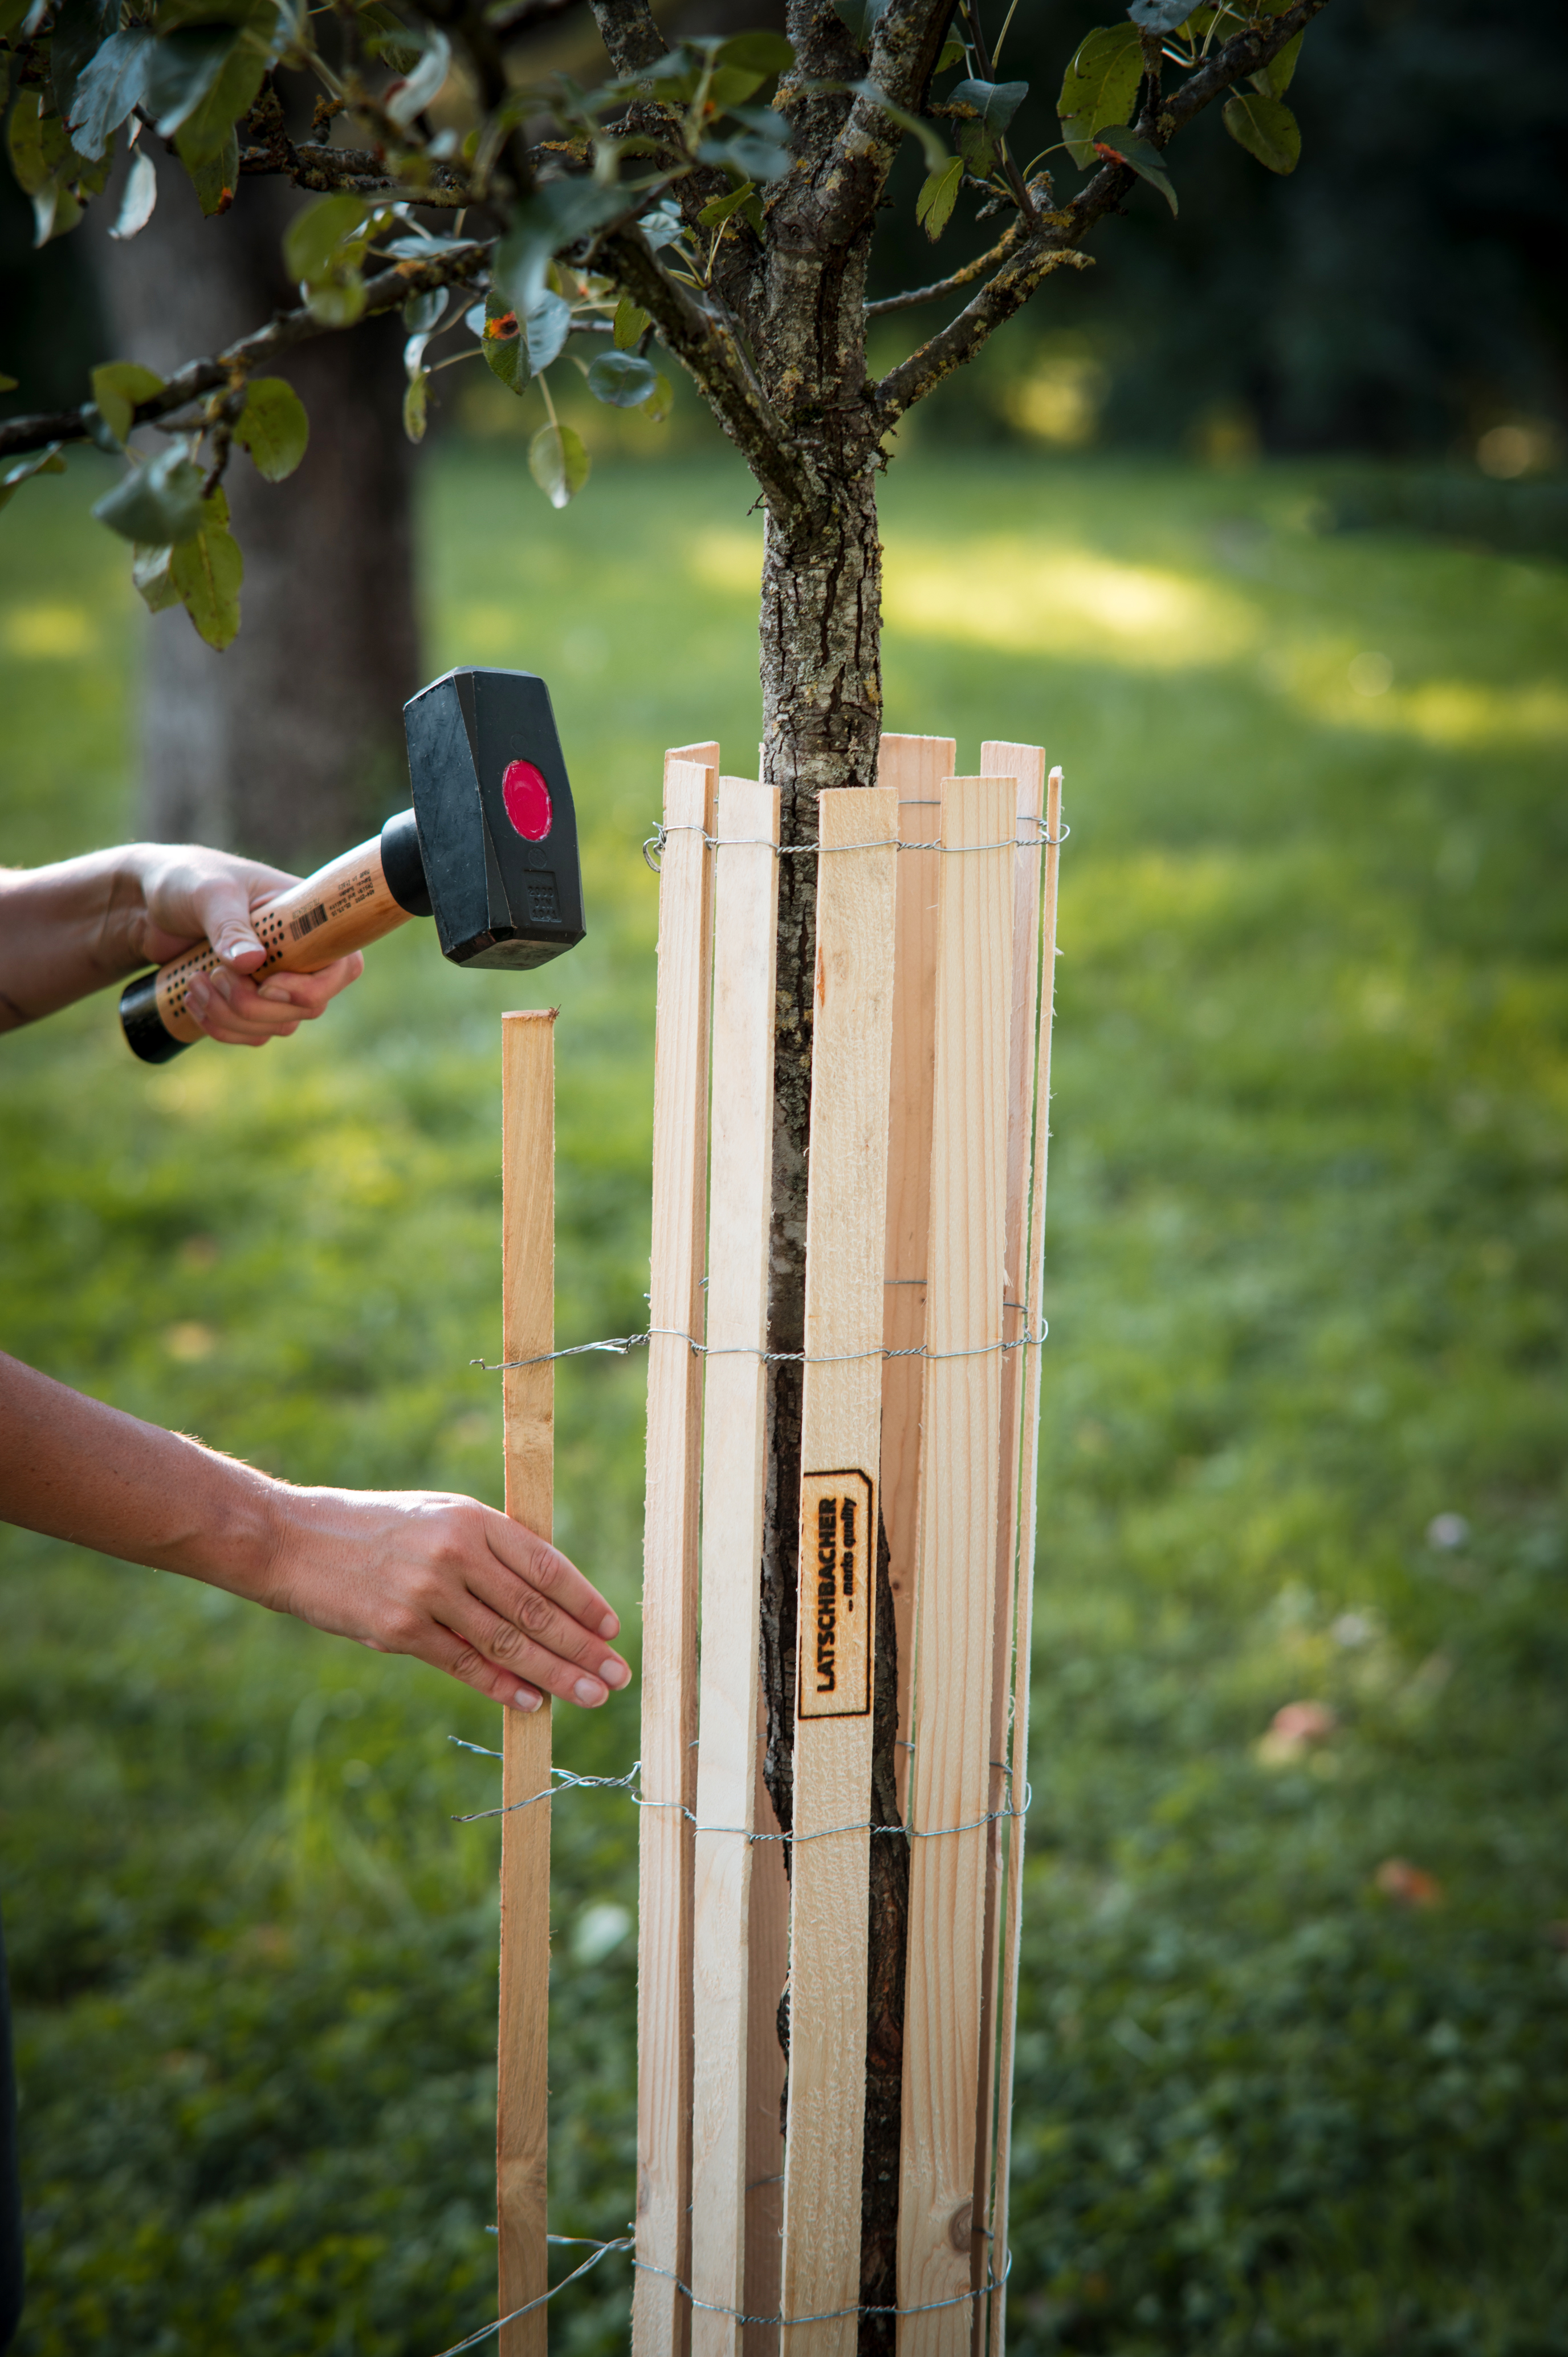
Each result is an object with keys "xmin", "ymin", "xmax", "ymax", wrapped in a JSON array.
[{"xmin": 877, "ymin": 735, "xmax": 958, "ymax": 1808}]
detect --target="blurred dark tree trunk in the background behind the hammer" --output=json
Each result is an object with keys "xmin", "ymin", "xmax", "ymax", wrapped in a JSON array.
[{"xmin": 94, "ymin": 137, "xmax": 420, "ymax": 867}]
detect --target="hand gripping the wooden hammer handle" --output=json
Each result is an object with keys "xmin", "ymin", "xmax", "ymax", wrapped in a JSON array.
[{"xmin": 137, "ymin": 844, "xmax": 365, "ymax": 1046}]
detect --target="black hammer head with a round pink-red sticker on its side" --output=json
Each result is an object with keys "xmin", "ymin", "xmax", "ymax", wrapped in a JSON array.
[{"xmin": 403, "ymin": 672, "xmax": 587, "ymax": 969}]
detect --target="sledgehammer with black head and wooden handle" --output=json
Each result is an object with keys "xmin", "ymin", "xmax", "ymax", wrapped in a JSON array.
[{"xmin": 120, "ymin": 672, "xmax": 585, "ymax": 1063}]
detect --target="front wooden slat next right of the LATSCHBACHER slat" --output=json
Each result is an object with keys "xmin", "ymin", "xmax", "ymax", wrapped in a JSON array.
[{"xmin": 898, "ymin": 778, "xmax": 1016, "ymax": 2357}]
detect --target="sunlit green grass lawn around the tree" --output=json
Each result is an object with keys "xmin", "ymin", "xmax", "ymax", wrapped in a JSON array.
[{"xmin": 0, "ymin": 448, "xmax": 1568, "ymax": 2357}]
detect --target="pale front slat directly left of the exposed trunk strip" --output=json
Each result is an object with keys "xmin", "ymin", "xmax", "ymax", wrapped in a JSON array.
[{"xmin": 691, "ymin": 778, "xmax": 778, "ymax": 2357}]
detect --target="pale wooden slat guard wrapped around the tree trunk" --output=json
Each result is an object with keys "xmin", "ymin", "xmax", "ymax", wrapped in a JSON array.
[{"xmin": 632, "ymin": 735, "xmax": 1061, "ymax": 2357}]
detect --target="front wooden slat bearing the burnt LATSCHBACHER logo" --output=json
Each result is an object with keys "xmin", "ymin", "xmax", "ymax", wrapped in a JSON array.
[{"xmin": 783, "ymin": 787, "xmax": 898, "ymax": 2357}]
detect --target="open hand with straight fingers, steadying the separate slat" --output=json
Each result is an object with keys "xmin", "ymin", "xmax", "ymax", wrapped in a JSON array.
[{"xmin": 264, "ymin": 1490, "xmax": 632, "ymax": 1711}]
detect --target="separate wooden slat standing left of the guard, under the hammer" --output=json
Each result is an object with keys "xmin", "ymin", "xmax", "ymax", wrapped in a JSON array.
[{"xmin": 495, "ymin": 1014, "xmax": 554, "ymax": 2357}]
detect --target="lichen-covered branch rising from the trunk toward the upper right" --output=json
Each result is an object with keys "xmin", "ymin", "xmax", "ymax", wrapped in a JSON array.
[{"xmin": 877, "ymin": 0, "xmax": 1327, "ymax": 426}]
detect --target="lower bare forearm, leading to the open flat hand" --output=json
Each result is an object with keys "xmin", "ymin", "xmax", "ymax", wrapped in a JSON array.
[{"xmin": 0, "ymin": 1353, "xmax": 280, "ymax": 1603}]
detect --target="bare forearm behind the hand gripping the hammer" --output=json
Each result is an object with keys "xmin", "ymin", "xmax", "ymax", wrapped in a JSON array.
[{"xmin": 0, "ymin": 844, "xmax": 146, "ymax": 1030}]
